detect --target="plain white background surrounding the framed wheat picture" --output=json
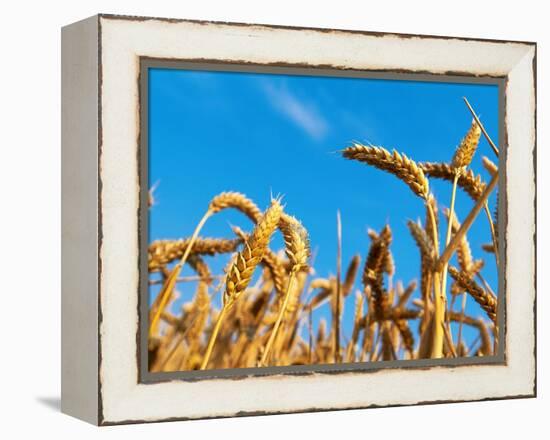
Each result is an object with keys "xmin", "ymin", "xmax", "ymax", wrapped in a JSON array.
[{"xmin": 0, "ymin": 0, "xmax": 550, "ymax": 440}]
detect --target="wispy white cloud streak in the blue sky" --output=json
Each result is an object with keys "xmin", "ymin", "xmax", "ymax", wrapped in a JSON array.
[{"xmin": 262, "ymin": 81, "xmax": 329, "ymax": 141}]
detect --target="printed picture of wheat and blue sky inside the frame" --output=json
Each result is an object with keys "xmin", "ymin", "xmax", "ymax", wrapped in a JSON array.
[{"xmin": 142, "ymin": 66, "xmax": 503, "ymax": 373}]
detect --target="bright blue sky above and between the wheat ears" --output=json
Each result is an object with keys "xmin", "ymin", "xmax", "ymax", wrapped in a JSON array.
[{"xmin": 149, "ymin": 68, "xmax": 498, "ymax": 352}]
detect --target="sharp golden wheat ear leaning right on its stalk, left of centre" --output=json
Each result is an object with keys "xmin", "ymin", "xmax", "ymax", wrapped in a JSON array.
[{"xmin": 200, "ymin": 199, "xmax": 283, "ymax": 370}]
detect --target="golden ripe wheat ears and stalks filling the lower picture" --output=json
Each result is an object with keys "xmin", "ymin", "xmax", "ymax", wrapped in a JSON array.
[{"xmin": 148, "ymin": 99, "xmax": 500, "ymax": 372}]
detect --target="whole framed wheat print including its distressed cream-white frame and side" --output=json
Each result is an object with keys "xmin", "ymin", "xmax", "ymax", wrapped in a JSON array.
[{"xmin": 62, "ymin": 15, "xmax": 536, "ymax": 425}]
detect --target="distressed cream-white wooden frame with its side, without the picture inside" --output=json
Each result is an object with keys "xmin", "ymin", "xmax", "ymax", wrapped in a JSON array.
[{"xmin": 62, "ymin": 15, "xmax": 536, "ymax": 425}]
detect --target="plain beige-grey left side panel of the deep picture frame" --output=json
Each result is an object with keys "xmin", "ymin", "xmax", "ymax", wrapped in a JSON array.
[{"xmin": 61, "ymin": 16, "xmax": 99, "ymax": 424}]
